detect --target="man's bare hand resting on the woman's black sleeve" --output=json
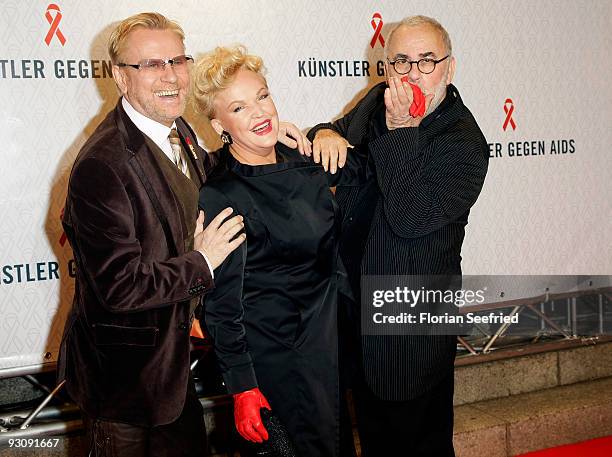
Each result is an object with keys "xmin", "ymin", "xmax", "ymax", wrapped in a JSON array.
[{"xmin": 193, "ymin": 208, "xmax": 246, "ymax": 270}]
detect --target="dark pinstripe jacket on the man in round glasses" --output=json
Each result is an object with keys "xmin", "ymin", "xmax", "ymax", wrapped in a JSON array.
[{"xmin": 309, "ymin": 83, "xmax": 488, "ymax": 400}]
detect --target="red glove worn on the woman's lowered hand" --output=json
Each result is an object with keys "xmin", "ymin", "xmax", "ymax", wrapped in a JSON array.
[{"xmin": 234, "ymin": 387, "xmax": 272, "ymax": 443}]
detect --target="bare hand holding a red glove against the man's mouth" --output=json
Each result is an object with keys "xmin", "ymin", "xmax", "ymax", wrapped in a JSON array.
[{"xmin": 385, "ymin": 77, "xmax": 433, "ymax": 130}]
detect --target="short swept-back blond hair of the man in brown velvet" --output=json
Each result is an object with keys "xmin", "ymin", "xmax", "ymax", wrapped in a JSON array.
[{"xmin": 108, "ymin": 13, "xmax": 185, "ymax": 65}]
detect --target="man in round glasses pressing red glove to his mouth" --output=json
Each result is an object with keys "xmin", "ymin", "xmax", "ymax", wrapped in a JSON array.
[{"xmin": 309, "ymin": 16, "xmax": 488, "ymax": 457}]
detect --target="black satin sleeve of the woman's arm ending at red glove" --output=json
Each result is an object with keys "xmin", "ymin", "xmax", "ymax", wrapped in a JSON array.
[{"xmin": 199, "ymin": 186, "xmax": 257, "ymax": 394}]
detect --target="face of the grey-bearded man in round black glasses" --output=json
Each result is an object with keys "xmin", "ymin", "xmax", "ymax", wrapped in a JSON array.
[{"xmin": 386, "ymin": 24, "xmax": 455, "ymax": 115}]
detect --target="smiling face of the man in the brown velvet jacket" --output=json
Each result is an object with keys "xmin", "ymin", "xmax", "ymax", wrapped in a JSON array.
[{"xmin": 113, "ymin": 28, "xmax": 190, "ymax": 127}]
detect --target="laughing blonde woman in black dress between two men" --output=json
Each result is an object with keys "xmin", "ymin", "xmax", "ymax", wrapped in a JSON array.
[{"xmin": 193, "ymin": 47, "xmax": 361, "ymax": 457}]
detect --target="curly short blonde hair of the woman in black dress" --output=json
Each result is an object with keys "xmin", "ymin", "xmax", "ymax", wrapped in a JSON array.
[{"xmin": 192, "ymin": 45, "xmax": 265, "ymax": 119}]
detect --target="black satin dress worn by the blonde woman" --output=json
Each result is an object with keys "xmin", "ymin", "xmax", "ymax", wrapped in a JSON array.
[{"xmin": 200, "ymin": 144, "xmax": 361, "ymax": 457}]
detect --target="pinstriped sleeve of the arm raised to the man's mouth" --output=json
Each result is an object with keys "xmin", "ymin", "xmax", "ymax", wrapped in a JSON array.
[{"xmin": 370, "ymin": 128, "xmax": 488, "ymax": 238}]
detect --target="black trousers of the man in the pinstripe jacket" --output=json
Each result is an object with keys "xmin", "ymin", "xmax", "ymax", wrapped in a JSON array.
[{"xmin": 353, "ymin": 373, "xmax": 455, "ymax": 457}]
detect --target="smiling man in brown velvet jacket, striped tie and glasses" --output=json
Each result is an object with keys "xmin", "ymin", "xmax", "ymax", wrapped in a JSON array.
[{"xmin": 58, "ymin": 13, "xmax": 308, "ymax": 457}]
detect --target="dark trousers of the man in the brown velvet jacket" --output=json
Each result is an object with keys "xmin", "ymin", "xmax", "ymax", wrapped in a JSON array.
[{"xmin": 85, "ymin": 379, "xmax": 208, "ymax": 457}]
